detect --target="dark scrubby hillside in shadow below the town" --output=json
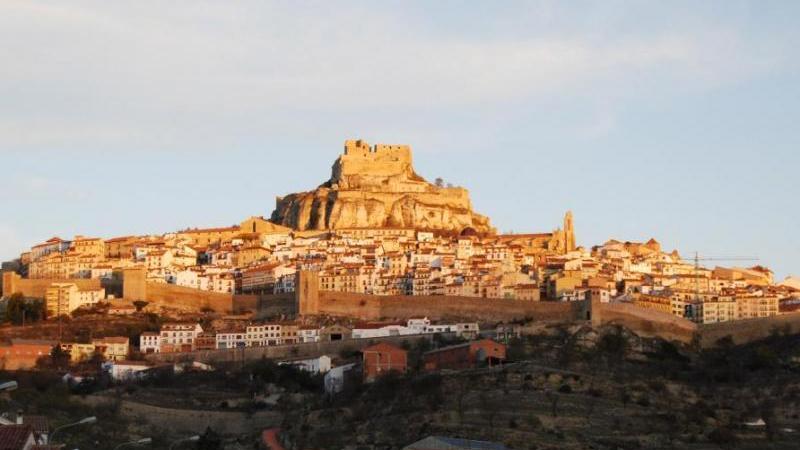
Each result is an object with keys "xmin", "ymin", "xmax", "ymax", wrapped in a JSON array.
[{"xmin": 0, "ymin": 324, "xmax": 800, "ymax": 450}]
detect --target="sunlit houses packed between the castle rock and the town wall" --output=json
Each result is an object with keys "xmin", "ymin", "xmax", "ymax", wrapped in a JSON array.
[{"xmin": 14, "ymin": 213, "xmax": 800, "ymax": 326}]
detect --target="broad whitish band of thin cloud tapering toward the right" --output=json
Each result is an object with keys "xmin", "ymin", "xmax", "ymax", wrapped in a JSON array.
[{"xmin": 0, "ymin": 2, "xmax": 782, "ymax": 151}]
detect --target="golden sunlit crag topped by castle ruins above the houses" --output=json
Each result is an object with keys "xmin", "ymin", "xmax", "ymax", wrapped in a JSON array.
[{"xmin": 271, "ymin": 140, "xmax": 494, "ymax": 233}]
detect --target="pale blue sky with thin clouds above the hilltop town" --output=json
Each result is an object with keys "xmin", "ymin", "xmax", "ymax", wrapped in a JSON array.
[{"xmin": 0, "ymin": 0, "xmax": 800, "ymax": 279}]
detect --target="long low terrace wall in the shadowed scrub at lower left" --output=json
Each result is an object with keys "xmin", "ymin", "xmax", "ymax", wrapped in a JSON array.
[{"xmin": 81, "ymin": 395, "xmax": 283, "ymax": 434}]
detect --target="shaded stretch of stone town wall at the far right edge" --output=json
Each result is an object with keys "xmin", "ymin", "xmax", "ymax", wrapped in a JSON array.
[{"xmin": 699, "ymin": 312, "xmax": 800, "ymax": 348}]
